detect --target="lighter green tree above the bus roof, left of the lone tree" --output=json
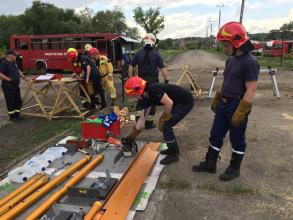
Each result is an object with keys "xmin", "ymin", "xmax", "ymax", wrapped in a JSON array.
[{"xmin": 93, "ymin": 8, "xmax": 128, "ymax": 34}]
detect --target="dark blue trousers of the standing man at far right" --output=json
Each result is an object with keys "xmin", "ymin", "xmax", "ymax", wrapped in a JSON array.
[{"xmin": 209, "ymin": 98, "xmax": 248, "ymax": 154}]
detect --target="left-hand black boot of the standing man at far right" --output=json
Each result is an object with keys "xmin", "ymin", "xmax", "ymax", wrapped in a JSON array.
[{"xmin": 192, "ymin": 147, "xmax": 219, "ymax": 173}]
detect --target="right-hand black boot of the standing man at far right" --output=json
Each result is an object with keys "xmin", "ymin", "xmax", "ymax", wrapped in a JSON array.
[{"xmin": 219, "ymin": 152, "xmax": 244, "ymax": 181}]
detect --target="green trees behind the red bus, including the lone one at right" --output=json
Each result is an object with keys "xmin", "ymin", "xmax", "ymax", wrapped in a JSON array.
[{"xmin": 0, "ymin": 1, "xmax": 164, "ymax": 48}]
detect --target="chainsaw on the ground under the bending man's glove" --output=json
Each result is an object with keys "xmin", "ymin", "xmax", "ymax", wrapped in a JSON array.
[{"xmin": 114, "ymin": 138, "xmax": 138, "ymax": 164}]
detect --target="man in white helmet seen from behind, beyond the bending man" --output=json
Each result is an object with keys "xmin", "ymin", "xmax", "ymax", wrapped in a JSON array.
[{"xmin": 128, "ymin": 33, "xmax": 169, "ymax": 129}]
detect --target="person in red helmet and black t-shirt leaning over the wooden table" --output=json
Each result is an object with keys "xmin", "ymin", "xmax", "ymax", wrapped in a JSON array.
[{"xmin": 66, "ymin": 48, "xmax": 106, "ymax": 109}]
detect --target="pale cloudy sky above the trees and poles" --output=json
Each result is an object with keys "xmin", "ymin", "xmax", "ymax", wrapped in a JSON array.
[{"xmin": 0, "ymin": 0, "xmax": 293, "ymax": 39}]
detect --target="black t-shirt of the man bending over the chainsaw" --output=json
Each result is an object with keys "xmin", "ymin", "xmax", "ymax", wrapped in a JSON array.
[{"xmin": 146, "ymin": 83, "xmax": 193, "ymax": 107}]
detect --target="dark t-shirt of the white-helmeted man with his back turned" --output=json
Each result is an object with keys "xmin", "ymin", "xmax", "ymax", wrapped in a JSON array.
[{"xmin": 131, "ymin": 48, "xmax": 165, "ymax": 83}]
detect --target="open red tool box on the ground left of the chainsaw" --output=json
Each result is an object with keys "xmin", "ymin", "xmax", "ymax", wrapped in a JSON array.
[{"xmin": 81, "ymin": 120, "xmax": 121, "ymax": 140}]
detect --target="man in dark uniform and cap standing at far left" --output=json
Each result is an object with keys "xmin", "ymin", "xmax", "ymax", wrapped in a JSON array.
[{"xmin": 0, "ymin": 50, "xmax": 25, "ymax": 122}]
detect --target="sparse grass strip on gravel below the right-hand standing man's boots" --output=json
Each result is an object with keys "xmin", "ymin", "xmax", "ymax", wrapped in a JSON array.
[{"xmin": 196, "ymin": 183, "xmax": 258, "ymax": 196}]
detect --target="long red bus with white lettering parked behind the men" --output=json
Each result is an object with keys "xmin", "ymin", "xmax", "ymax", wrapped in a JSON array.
[{"xmin": 10, "ymin": 33, "xmax": 139, "ymax": 72}]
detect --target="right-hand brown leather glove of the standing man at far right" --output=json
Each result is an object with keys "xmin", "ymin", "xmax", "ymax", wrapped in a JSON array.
[{"xmin": 231, "ymin": 100, "xmax": 252, "ymax": 127}]
